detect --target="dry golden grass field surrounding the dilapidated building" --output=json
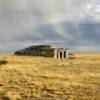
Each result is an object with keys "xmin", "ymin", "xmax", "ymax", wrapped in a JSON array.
[{"xmin": 0, "ymin": 53, "xmax": 100, "ymax": 100}]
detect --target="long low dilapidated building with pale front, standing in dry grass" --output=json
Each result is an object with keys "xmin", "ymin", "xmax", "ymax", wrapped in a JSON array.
[{"xmin": 15, "ymin": 45, "xmax": 69, "ymax": 59}]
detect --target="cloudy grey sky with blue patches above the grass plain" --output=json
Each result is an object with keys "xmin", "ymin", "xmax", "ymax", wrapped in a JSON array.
[{"xmin": 0, "ymin": 0, "xmax": 100, "ymax": 51}]
